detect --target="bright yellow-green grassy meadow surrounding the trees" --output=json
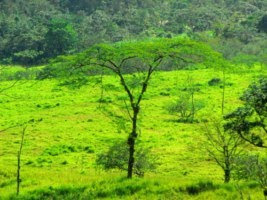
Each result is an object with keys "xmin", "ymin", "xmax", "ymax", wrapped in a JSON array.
[{"xmin": 0, "ymin": 69, "xmax": 263, "ymax": 199}]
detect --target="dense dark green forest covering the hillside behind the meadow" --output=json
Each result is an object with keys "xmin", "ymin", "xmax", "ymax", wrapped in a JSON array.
[{"xmin": 0, "ymin": 0, "xmax": 267, "ymax": 66}]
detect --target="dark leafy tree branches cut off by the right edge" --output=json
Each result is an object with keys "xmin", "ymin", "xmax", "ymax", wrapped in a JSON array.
[{"xmin": 224, "ymin": 77, "xmax": 267, "ymax": 148}]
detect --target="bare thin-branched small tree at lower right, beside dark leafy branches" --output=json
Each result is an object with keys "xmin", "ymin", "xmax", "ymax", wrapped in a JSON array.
[{"xmin": 204, "ymin": 121, "xmax": 242, "ymax": 183}]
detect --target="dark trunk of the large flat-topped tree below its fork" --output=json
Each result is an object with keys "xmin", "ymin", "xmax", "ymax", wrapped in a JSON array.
[{"xmin": 127, "ymin": 106, "xmax": 139, "ymax": 178}]
